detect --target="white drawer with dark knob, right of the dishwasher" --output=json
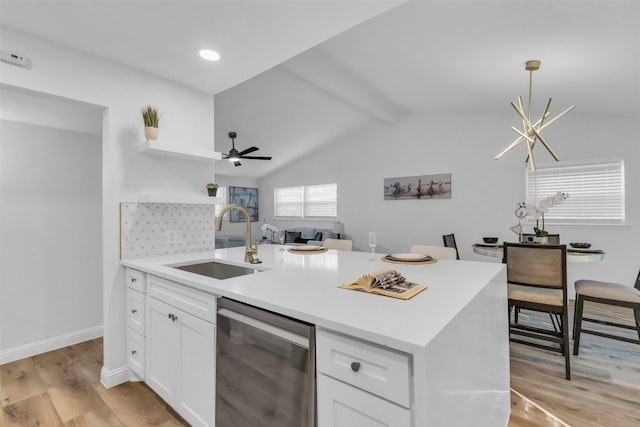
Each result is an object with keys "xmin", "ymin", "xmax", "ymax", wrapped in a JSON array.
[{"xmin": 316, "ymin": 330, "xmax": 411, "ymax": 408}]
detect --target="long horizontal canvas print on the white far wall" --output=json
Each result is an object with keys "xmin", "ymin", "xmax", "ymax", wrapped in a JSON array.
[{"xmin": 384, "ymin": 173, "xmax": 451, "ymax": 200}]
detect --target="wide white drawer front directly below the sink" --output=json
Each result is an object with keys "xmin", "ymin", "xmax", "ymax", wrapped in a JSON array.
[{"xmin": 147, "ymin": 276, "xmax": 216, "ymax": 324}]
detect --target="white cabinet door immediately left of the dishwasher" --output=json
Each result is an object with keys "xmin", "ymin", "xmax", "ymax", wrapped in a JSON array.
[{"xmin": 177, "ymin": 312, "xmax": 216, "ymax": 427}]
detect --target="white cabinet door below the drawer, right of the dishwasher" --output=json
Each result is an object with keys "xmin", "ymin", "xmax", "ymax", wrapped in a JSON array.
[{"xmin": 318, "ymin": 374, "xmax": 411, "ymax": 427}]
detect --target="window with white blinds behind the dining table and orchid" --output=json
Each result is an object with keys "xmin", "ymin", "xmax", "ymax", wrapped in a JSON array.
[{"xmin": 526, "ymin": 159, "xmax": 625, "ymax": 224}]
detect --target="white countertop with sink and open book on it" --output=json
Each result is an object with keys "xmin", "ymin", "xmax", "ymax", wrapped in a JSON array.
[{"xmin": 121, "ymin": 245, "xmax": 506, "ymax": 353}]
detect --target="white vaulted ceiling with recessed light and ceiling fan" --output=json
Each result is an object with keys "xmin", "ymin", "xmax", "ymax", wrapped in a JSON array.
[{"xmin": 0, "ymin": 0, "xmax": 640, "ymax": 177}]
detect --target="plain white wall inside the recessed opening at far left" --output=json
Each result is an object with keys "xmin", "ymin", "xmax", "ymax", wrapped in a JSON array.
[{"xmin": 0, "ymin": 118, "xmax": 102, "ymax": 363}]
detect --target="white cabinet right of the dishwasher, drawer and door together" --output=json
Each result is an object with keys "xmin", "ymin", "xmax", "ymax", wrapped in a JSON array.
[{"xmin": 316, "ymin": 330, "xmax": 412, "ymax": 427}]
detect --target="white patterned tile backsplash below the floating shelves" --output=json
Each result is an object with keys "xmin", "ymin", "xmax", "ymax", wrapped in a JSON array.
[{"xmin": 120, "ymin": 202, "xmax": 215, "ymax": 259}]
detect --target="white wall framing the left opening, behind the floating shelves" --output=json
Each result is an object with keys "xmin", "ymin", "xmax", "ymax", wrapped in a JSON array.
[{"xmin": 0, "ymin": 27, "xmax": 214, "ymax": 385}]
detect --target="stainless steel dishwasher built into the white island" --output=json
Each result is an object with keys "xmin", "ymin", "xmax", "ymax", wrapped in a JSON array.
[{"xmin": 216, "ymin": 298, "xmax": 316, "ymax": 427}]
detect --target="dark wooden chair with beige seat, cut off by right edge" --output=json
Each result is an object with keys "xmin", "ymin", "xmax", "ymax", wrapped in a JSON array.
[{"xmin": 573, "ymin": 272, "xmax": 640, "ymax": 356}]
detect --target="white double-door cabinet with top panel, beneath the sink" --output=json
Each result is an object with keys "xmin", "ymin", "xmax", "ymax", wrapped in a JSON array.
[{"xmin": 145, "ymin": 276, "xmax": 215, "ymax": 427}]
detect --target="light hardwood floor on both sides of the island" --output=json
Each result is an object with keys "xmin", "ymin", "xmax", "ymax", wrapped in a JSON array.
[{"xmin": 0, "ymin": 304, "xmax": 640, "ymax": 427}]
